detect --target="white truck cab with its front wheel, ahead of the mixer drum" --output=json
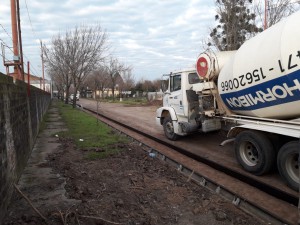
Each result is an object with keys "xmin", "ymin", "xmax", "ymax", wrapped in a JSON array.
[{"xmin": 156, "ymin": 68, "xmax": 221, "ymax": 140}]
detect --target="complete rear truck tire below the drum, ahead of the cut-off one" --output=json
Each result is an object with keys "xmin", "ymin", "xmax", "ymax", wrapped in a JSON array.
[{"xmin": 234, "ymin": 131, "xmax": 276, "ymax": 175}]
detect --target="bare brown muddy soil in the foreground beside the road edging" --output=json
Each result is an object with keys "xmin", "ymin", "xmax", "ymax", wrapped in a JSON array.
[{"xmin": 4, "ymin": 134, "xmax": 265, "ymax": 225}]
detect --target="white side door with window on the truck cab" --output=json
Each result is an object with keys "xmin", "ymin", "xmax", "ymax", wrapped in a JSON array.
[{"xmin": 168, "ymin": 74, "xmax": 184, "ymax": 115}]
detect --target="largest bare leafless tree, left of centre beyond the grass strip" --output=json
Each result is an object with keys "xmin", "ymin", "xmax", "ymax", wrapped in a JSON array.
[{"xmin": 46, "ymin": 25, "xmax": 107, "ymax": 107}]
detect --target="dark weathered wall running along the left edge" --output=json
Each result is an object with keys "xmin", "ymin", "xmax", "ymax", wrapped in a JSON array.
[{"xmin": 0, "ymin": 73, "xmax": 51, "ymax": 224}]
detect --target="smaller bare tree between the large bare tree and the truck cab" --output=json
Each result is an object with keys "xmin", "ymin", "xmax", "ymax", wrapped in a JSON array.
[{"xmin": 107, "ymin": 57, "xmax": 130, "ymax": 100}]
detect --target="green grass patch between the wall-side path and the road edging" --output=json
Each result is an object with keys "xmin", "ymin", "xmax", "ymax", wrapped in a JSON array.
[{"xmin": 58, "ymin": 103, "xmax": 128, "ymax": 160}]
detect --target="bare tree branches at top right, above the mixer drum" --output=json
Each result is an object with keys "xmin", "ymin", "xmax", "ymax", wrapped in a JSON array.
[{"xmin": 253, "ymin": 0, "xmax": 300, "ymax": 27}]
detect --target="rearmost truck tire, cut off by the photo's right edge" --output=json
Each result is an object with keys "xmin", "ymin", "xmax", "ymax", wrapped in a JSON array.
[{"xmin": 277, "ymin": 141, "xmax": 300, "ymax": 191}]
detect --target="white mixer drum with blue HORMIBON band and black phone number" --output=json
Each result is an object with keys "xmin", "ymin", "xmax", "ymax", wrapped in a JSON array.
[{"xmin": 218, "ymin": 11, "xmax": 300, "ymax": 119}]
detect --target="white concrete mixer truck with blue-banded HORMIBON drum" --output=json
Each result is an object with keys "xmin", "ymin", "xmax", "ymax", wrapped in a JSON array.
[{"xmin": 156, "ymin": 12, "xmax": 300, "ymax": 190}]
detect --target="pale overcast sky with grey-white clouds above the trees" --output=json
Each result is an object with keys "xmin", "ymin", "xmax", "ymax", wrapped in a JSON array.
[{"xmin": 0, "ymin": 0, "xmax": 215, "ymax": 80}]
